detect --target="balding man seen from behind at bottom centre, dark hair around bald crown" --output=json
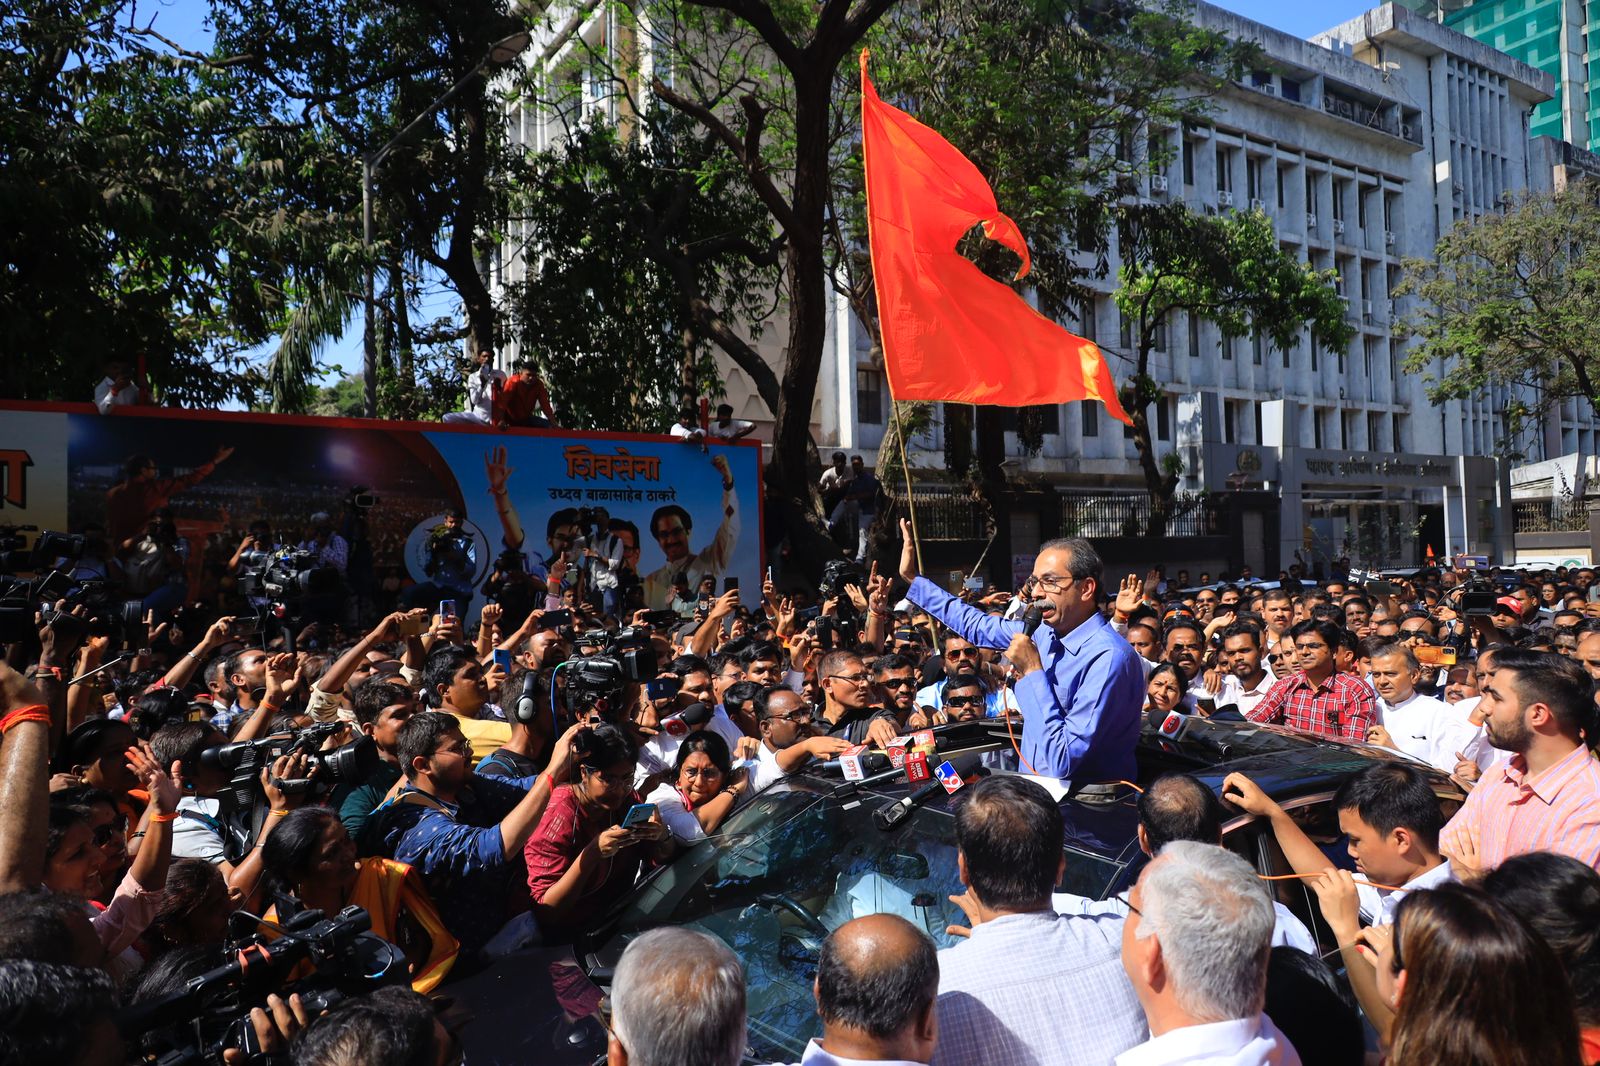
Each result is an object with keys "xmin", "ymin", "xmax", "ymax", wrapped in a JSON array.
[{"xmin": 761, "ymin": 914, "xmax": 939, "ymax": 1066}]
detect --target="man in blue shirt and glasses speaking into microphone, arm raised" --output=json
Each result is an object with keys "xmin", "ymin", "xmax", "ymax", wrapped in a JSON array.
[{"xmin": 901, "ymin": 519, "xmax": 1144, "ymax": 784}]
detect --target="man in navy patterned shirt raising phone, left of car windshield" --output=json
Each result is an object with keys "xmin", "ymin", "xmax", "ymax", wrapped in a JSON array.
[{"xmin": 368, "ymin": 711, "xmax": 578, "ymax": 954}]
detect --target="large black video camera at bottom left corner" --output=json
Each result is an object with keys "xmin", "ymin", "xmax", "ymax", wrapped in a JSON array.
[{"xmin": 117, "ymin": 906, "xmax": 408, "ymax": 1066}]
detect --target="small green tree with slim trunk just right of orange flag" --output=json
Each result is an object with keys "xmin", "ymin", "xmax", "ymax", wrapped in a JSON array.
[{"xmin": 1115, "ymin": 205, "xmax": 1355, "ymax": 535}]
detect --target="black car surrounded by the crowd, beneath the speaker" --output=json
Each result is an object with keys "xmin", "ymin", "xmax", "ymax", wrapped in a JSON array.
[{"xmin": 450, "ymin": 719, "xmax": 1464, "ymax": 1064}]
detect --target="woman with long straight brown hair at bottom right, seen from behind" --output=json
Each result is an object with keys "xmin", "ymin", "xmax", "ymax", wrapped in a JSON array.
[{"xmin": 1362, "ymin": 884, "xmax": 1579, "ymax": 1066}]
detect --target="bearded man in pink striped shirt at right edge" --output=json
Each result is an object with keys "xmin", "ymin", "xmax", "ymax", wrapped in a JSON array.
[{"xmin": 1442, "ymin": 648, "xmax": 1600, "ymax": 872}]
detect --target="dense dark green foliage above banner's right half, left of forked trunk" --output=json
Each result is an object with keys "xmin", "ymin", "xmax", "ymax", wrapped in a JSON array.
[{"xmin": 510, "ymin": 109, "xmax": 779, "ymax": 432}]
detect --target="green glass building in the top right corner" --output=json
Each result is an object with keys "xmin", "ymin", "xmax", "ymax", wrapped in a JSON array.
[{"xmin": 1403, "ymin": 0, "xmax": 1600, "ymax": 152}]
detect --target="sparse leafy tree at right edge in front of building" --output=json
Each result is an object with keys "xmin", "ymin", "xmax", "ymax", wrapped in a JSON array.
[{"xmin": 1395, "ymin": 184, "xmax": 1600, "ymax": 439}]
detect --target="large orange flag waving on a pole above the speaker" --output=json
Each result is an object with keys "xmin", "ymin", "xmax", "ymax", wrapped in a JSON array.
[{"xmin": 861, "ymin": 50, "xmax": 1131, "ymax": 423}]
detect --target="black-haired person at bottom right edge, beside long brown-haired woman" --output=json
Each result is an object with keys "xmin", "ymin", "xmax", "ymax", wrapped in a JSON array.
[{"xmin": 1483, "ymin": 852, "xmax": 1600, "ymax": 1066}]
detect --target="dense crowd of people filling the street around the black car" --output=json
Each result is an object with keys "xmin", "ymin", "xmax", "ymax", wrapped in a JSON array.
[{"xmin": 0, "ymin": 492, "xmax": 1600, "ymax": 1066}]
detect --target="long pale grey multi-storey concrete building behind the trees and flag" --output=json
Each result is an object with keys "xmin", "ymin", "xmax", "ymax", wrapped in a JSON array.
[{"xmin": 496, "ymin": 3, "xmax": 1600, "ymax": 573}]
